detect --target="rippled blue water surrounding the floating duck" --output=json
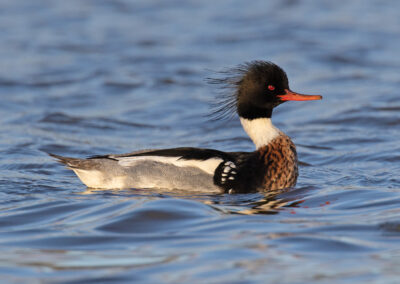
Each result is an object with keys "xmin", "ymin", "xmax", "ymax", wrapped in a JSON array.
[{"xmin": 0, "ymin": 0, "xmax": 400, "ymax": 283}]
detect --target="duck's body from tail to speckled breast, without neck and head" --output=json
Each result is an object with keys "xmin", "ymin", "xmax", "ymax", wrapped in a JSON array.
[{"xmin": 53, "ymin": 118, "xmax": 298, "ymax": 193}]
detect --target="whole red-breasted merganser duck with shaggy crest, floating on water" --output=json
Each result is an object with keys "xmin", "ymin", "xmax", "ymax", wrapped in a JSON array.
[{"xmin": 51, "ymin": 61, "xmax": 322, "ymax": 193}]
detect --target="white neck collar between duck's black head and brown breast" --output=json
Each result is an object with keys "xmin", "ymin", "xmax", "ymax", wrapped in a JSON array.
[{"xmin": 240, "ymin": 117, "xmax": 280, "ymax": 149}]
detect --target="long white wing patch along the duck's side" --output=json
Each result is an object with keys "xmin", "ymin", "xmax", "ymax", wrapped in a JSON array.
[{"xmin": 116, "ymin": 156, "xmax": 223, "ymax": 175}]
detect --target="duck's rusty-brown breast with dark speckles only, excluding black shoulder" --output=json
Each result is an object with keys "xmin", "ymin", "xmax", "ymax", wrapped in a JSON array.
[{"xmin": 257, "ymin": 134, "xmax": 299, "ymax": 191}]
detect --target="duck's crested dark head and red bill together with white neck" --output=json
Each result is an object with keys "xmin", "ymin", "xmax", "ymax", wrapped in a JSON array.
[{"xmin": 209, "ymin": 61, "xmax": 322, "ymax": 149}]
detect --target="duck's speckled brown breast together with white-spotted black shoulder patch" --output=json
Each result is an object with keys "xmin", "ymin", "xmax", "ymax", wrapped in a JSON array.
[{"xmin": 214, "ymin": 133, "xmax": 298, "ymax": 193}]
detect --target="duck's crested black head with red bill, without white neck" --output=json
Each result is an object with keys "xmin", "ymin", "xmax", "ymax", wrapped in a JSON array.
[{"xmin": 212, "ymin": 61, "xmax": 322, "ymax": 119}]
